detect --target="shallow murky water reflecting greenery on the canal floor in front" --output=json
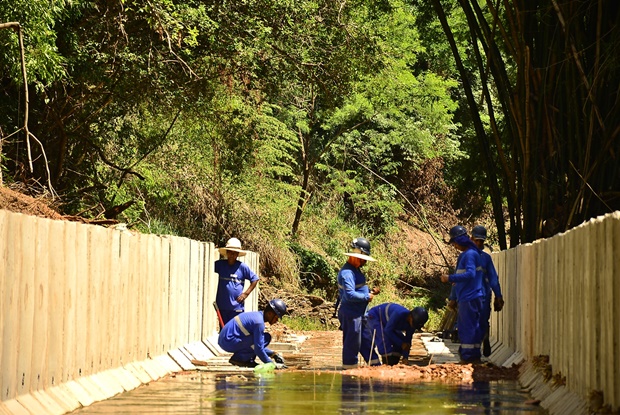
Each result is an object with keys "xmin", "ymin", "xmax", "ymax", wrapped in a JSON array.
[{"xmin": 72, "ymin": 371, "xmax": 546, "ymax": 415}]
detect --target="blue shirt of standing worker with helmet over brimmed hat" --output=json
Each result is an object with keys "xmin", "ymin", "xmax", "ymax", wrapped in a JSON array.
[{"xmin": 338, "ymin": 262, "xmax": 370, "ymax": 316}]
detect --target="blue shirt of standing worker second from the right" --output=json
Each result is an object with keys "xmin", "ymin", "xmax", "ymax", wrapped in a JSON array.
[{"xmin": 448, "ymin": 248, "xmax": 484, "ymax": 302}]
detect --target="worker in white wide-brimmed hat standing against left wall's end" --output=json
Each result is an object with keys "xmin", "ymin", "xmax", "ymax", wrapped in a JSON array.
[{"xmin": 215, "ymin": 238, "xmax": 259, "ymax": 326}]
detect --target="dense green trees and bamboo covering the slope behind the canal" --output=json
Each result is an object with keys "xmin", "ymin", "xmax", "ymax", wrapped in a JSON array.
[{"xmin": 0, "ymin": 0, "xmax": 620, "ymax": 300}]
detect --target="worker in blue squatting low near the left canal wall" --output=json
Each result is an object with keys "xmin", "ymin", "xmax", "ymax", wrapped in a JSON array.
[{"xmin": 217, "ymin": 298, "xmax": 286, "ymax": 367}]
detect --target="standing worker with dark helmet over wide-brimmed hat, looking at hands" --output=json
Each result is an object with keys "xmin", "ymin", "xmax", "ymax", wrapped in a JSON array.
[{"xmin": 338, "ymin": 238, "xmax": 381, "ymax": 369}]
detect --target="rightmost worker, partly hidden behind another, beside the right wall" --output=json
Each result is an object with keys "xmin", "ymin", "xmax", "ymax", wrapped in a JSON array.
[{"xmin": 471, "ymin": 225, "xmax": 504, "ymax": 357}]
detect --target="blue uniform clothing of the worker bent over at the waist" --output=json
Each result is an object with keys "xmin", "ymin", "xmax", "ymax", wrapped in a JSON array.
[{"xmin": 368, "ymin": 303, "xmax": 415, "ymax": 359}]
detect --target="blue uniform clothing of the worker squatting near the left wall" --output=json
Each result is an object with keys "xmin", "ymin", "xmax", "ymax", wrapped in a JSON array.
[{"xmin": 217, "ymin": 311, "xmax": 273, "ymax": 363}]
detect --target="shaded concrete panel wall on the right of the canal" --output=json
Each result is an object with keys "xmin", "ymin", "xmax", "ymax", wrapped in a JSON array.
[{"xmin": 490, "ymin": 212, "xmax": 620, "ymax": 414}]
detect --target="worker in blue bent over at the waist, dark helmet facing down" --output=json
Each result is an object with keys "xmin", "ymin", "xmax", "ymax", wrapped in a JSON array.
[{"xmin": 368, "ymin": 303, "xmax": 428, "ymax": 366}]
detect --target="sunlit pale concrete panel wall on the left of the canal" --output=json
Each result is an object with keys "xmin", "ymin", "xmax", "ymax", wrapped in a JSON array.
[{"xmin": 0, "ymin": 210, "xmax": 259, "ymax": 415}]
